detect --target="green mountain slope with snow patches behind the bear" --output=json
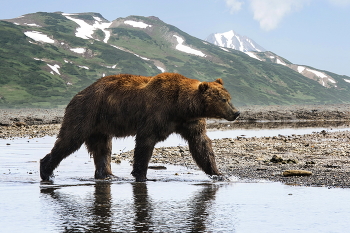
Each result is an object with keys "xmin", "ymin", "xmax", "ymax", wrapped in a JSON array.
[{"xmin": 0, "ymin": 12, "xmax": 350, "ymax": 107}]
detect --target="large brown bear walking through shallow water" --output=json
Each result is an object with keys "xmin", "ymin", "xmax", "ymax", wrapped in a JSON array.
[{"xmin": 40, "ymin": 73, "xmax": 239, "ymax": 182}]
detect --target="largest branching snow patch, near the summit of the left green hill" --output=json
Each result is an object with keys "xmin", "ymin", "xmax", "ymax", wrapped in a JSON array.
[{"xmin": 62, "ymin": 13, "xmax": 112, "ymax": 43}]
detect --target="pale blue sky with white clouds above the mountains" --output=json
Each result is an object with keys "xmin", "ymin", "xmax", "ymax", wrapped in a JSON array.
[{"xmin": 0, "ymin": 0, "xmax": 350, "ymax": 76}]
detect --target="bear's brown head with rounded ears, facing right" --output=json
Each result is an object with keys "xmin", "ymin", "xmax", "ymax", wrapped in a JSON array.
[{"xmin": 199, "ymin": 79, "xmax": 240, "ymax": 121}]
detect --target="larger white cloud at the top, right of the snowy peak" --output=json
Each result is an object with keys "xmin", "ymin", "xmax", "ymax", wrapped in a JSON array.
[{"xmin": 250, "ymin": 0, "xmax": 311, "ymax": 31}]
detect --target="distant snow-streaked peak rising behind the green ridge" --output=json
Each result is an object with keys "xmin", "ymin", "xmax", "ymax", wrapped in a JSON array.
[{"xmin": 206, "ymin": 30, "xmax": 266, "ymax": 52}]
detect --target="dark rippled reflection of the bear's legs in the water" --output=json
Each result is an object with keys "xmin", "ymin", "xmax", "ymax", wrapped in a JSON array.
[{"xmin": 41, "ymin": 181, "xmax": 219, "ymax": 232}]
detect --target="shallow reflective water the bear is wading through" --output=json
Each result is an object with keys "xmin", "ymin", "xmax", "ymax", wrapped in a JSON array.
[{"xmin": 0, "ymin": 124, "xmax": 350, "ymax": 232}]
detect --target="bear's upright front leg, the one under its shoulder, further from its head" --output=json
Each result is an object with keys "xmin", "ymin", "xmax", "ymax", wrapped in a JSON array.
[{"xmin": 131, "ymin": 134, "xmax": 156, "ymax": 182}]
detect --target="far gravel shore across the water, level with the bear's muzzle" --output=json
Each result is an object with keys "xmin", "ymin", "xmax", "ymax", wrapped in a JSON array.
[{"xmin": 0, "ymin": 104, "xmax": 350, "ymax": 138}]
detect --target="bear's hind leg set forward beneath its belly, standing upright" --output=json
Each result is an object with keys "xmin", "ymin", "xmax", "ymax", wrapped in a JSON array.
[{"xmin": 85, "ymin": 133, "xmax": 113, "ymax": 179}]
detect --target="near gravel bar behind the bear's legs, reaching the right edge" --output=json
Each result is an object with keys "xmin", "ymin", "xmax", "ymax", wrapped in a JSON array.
[{"xmin": 113, "ymin": 131, "xmax": 350, "ymax": 188}]
